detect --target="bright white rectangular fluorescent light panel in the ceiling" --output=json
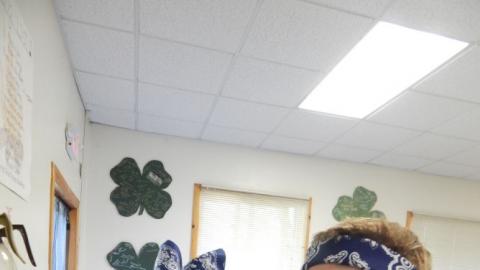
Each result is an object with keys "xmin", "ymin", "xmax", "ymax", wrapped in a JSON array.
[{"xmin": 300, "ymin": 22, "xmax": 468, "ymax": 118}]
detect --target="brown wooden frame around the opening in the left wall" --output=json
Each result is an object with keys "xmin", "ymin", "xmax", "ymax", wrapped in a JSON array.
[{"xmin": 48, "ymin": 162, "xmax": 80, "ymax": 270}]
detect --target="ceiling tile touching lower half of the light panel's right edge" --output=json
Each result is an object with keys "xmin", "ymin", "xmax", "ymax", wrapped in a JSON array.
[{"xmin": 369, "ymin": 91, "xmax": 475, "ymax": 131}]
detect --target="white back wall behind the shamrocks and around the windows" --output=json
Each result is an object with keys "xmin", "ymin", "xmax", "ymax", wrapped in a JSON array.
[{"xmin": 80, "ymin": 125, "xmax": 480, "ymax": 270}]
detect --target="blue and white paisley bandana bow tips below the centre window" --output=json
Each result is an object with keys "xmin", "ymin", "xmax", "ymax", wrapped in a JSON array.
[{"xmin": 155, "ymin": 240, "xmax": 226, "ymax": 270}]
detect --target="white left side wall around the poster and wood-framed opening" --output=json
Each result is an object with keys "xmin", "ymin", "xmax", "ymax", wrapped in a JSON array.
[{"xmin": 0, "ymin": 0, "xmax": 84, "ymax": 270}]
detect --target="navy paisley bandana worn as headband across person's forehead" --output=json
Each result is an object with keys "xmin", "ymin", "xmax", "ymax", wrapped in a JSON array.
[{"xmin": 302, "ymin": 235, "xmax": 416, "ymax": 270}]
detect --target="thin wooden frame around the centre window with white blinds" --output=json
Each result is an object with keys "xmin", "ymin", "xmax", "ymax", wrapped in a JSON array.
[{"xmin": 190, "ymin": 183, "xmax": 312, "ymax": 259}]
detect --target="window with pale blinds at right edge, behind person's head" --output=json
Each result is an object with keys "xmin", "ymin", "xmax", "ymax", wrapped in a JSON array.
[{"xmin": 411, "ymin": 213, "xmax": 480, "ymax": 270}]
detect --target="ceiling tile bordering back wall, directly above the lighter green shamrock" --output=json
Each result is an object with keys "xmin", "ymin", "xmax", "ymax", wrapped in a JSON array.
[{"xmin": 318, "ymin": 144, "xmax": 382, "ymax": 163}]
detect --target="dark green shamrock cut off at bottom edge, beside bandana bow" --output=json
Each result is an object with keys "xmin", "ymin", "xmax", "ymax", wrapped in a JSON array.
[{"xmin": 107, "ymin": 242, "xmax": 160, "ymax": 270}]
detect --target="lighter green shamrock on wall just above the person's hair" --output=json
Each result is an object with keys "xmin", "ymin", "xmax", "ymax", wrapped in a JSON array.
[{"xmin": 332, "ymin": 187, "xmax": 385, "ymax": 221}]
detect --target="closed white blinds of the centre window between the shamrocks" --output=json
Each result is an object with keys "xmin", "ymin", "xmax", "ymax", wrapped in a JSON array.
[{"xmin": 192, "ymin": 187, "xmax": 310, "ymax": 270}]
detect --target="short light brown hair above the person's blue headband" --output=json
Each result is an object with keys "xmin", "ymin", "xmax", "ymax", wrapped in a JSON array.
[{"xmin": 313, "ymin": 218, "xmax": 432, "ymax": 270}]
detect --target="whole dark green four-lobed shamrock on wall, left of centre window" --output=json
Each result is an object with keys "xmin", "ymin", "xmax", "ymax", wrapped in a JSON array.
[{"xmin": 110, "ymin": 158, "xmax": 172, "ymax": 219}]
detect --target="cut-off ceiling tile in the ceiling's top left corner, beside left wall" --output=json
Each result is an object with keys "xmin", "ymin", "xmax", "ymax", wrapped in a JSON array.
[{"xmin": 55, "ymin": 0, "xmax": 134, "ymax": 31}]
